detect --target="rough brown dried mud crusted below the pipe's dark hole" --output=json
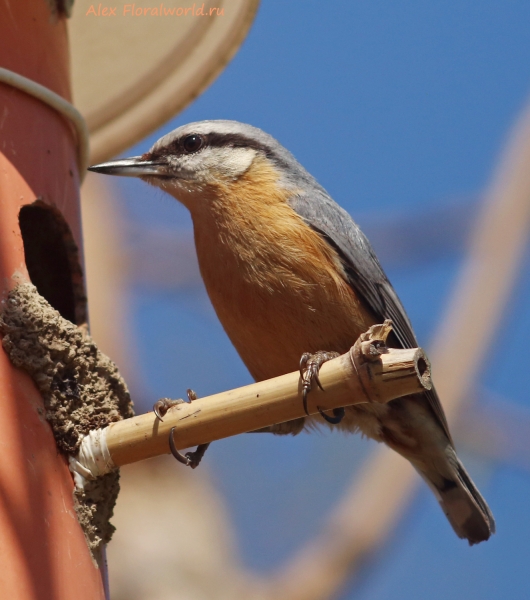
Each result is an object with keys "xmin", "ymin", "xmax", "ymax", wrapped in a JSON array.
[{"xmin": 0, "ymin": 283, "xmax": 134, "ymax": 556}]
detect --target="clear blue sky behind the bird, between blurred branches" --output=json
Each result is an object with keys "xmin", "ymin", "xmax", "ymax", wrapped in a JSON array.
[{"xmin": 110, "ymin": 0, "xmax": 530, "ymax": 600}]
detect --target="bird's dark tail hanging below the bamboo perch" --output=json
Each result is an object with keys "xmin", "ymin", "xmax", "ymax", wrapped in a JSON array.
[{"xmin": 415, "ymin": 445, "xmax": 495, "ymax": 546}]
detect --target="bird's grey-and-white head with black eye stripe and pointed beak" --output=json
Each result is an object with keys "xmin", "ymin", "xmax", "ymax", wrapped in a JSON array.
[{"xmin": 89, "ymin": 121, "xmax": 314, "ymax": 209}]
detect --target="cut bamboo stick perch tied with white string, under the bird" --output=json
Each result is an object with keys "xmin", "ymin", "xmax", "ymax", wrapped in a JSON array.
[{"xmin": 74, "ymin": 321, "xmax": 432, "ymax": 475}]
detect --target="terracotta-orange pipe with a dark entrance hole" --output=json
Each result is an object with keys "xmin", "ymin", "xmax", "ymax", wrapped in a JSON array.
[{"xmin": 0, "ymin": 0, "xmax": 105, "ymax": 600}]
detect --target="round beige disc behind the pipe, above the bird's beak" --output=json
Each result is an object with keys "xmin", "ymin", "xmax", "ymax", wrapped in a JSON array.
[{"xmin": 68, "ymin": 0, "xmax": 259, "ymax": 163}]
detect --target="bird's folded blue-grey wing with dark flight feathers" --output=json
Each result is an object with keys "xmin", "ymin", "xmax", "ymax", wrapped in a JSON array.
[{"xmin": 289, "ymin": 188, "xmax": 452, "ymax": 441}]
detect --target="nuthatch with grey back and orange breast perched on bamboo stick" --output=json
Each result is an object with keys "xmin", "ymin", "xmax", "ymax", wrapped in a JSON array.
[{"xmin": 89, "ymin": 120, "xmax": 495, "ymax": 545}]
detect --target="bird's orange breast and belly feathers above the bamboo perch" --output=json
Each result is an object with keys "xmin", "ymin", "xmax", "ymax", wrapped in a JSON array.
[{"xmin": 188, "ymin": 159, "xmax": 374, "ymax": 380}]
